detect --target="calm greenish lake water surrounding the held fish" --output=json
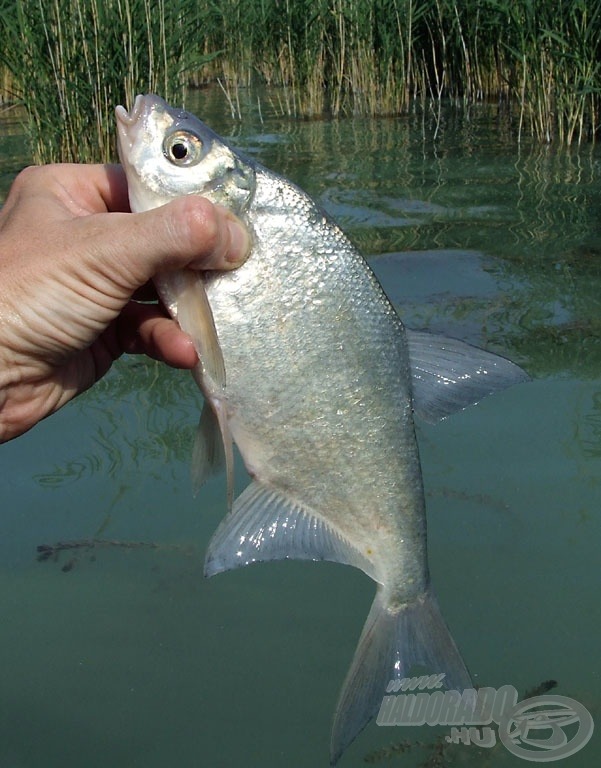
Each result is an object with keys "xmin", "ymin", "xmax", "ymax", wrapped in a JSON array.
[{"xmin": 0, "ymin": 94, "xmax": 601, "ymax": 768}]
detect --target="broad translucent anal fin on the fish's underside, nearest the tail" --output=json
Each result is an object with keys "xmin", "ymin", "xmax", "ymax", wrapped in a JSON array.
[{"xmin": 205, "ymin": 481, "xmax": 375, "ymax": 578}]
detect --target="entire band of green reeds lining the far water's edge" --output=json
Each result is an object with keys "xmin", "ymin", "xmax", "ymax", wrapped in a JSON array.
[{"xmin": 0, "ymin": 0, "xmax": 601, "ymax": 162}]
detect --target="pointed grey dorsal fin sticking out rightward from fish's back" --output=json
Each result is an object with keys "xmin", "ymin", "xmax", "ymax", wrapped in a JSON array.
[{"xmin": 407, "ymin": 330, "xmax": 529, "ymax": 422}]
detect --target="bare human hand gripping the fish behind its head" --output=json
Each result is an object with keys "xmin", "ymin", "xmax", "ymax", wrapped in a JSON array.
[{"xmin": 0, "ymin": 165, "xmax": 249, "ymax": 442}]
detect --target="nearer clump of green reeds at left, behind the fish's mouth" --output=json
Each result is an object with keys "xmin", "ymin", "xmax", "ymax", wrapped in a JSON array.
[{"xmin": 0, "ymin": 0, "xmax": 204, "ymax": 163}]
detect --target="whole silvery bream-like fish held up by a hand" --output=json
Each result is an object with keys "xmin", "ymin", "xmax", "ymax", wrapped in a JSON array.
[{"xmin": 116, "ymin": 94, "xmax": 528, "ymax": 765}]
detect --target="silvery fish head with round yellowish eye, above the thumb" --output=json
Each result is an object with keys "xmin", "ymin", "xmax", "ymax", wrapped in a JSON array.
[{"xmin": 115, "ymin": 94, "xmax": 255, "ymax": 215}]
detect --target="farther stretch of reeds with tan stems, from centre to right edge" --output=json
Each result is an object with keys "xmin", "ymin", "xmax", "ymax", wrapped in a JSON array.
[{"xmin": 197, "ymin": 0, "xmax": 601, "ymax": 143}]
